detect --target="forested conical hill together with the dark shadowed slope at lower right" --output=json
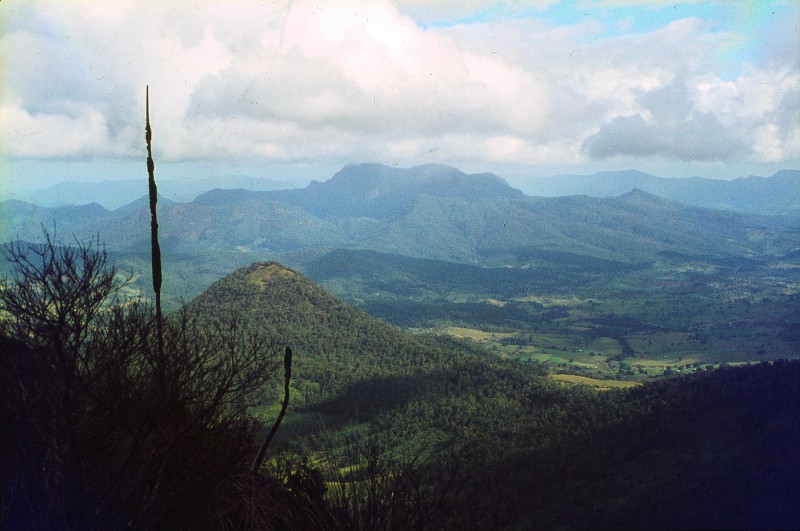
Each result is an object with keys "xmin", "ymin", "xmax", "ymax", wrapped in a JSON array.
[{"xmin": 181, "ymin": 263, "xmax": 800, "ymax": 528}]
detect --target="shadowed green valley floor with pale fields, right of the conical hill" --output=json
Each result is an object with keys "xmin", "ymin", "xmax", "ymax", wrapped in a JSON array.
[{"xmin": 296, "ymin": 246, "xmax": 800, "ymax": 380}]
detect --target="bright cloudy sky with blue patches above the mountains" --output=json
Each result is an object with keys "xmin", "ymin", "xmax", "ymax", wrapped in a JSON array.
[{"xmin": 0, "ymin": 0, "xmax": 800, "ymax": 195}]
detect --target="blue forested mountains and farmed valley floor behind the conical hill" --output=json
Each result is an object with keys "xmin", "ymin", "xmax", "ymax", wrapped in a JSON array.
[{"xmin": 0, "ymin": 165, "xmax": 800, "ymax": 370}]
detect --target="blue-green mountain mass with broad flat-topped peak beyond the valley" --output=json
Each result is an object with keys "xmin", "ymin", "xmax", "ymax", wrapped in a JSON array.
[{"xmin": 0, "ymin": 164, "xmax": 796, "ymax": 266}]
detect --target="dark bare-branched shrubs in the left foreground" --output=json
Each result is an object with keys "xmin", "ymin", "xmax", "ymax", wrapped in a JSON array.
[{"xmin": 0, "ymin": 232, "xmax": 294, "ymax": 529}]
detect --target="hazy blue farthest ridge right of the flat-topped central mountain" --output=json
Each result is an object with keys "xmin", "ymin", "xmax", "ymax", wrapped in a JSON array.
[{"xmin": 525, "ymin": 170, "xmax": 800, "ymax": 217}]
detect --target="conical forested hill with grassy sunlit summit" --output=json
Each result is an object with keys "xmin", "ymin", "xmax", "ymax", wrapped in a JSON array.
[{"xmin": 188, "ymin": 262, "xmax": 472, "ymax": 402}]
